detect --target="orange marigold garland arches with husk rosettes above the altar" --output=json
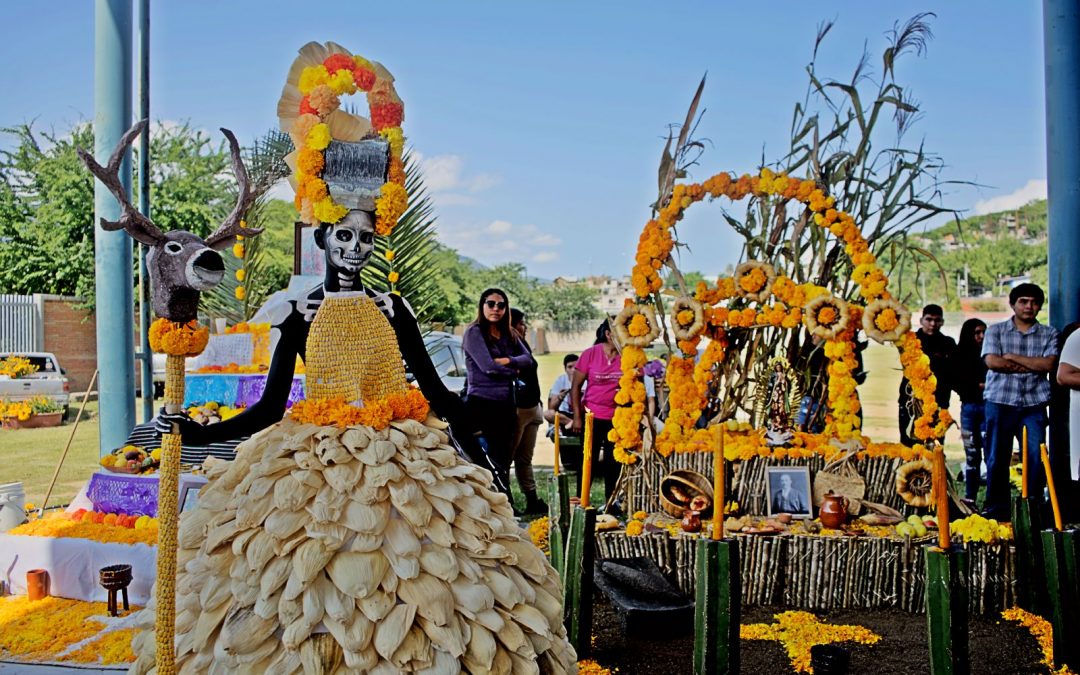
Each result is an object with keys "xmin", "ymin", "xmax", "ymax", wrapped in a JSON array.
[{"xmin": 609, "ymin": 168, "xmax": 953, "ymax": 464}]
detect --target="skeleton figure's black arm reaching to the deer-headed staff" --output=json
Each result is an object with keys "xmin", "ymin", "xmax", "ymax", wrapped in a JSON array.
[{"xmin": 180, "ymin": 311, "xmax": 311, "ymax": 445}]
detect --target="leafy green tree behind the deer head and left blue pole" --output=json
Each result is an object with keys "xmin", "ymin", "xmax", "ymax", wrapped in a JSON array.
[{"xmin": 0, "ymin": 122, "xmax": 234, "ymax": 306}]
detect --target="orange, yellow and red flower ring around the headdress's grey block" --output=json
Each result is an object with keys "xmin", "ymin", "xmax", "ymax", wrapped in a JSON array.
[{"xmin": 278, "ymin": 42, "xmax": 408, "ymax": 235}]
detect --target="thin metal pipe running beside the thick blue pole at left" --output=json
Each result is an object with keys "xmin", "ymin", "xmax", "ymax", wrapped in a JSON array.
[{"xmin": 135, "ymin": 0, "xmax": 153, "ymax": 422}]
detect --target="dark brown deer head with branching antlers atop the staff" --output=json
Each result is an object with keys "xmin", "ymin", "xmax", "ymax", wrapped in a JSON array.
[{"xmin": 79, "ymin": 120, "xmax": 262, "ymax": 323}]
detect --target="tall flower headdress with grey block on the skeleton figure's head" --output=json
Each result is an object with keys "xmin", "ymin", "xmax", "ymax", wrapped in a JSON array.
[{"xmin": 278, "ymin": 42, "xmax": 408, "ymax": 235}]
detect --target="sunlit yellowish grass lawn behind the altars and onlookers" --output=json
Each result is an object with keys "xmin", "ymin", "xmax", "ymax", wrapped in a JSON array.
[{"xmin": 0, "ymin": 343, "xmax": 963, "ymax": 505}]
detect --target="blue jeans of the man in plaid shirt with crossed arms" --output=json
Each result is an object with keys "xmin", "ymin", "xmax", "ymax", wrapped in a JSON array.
[{"xmin": 983, "ymin": 401, "xmax": 1047, "ymax": 521}]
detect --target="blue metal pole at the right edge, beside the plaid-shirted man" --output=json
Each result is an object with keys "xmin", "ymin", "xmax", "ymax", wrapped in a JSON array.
[{"xmin": 1042, "ymin": 0, "xmax": 1080, "ymax": 329}]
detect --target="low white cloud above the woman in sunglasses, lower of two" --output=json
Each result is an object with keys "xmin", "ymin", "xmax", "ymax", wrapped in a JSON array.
[{"xmin": 438, "ymin": 220, "xmax": 563, "ymax": 265}]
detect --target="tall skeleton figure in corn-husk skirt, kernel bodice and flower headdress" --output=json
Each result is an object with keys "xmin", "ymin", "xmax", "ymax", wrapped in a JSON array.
[{"xmin": 132, "ymin": 42, "xmax": 577, "ymax": 673}]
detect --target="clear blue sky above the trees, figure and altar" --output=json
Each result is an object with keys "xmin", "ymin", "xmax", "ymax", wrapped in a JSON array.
[{"xmin": 0, "ymin": 0, "xmax": 1045, "ymax": 278}]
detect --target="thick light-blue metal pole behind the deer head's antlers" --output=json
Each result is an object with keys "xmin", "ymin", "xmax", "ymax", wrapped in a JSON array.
[{"xmin": 94, "ymin": 0, "xmax": 135, "ymax": 456}]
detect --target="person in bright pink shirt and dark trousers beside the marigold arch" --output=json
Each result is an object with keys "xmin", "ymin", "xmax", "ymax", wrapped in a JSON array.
[{"xmin": 570, "ymin": 321, "xmax": 622, "ymax": 500}]
